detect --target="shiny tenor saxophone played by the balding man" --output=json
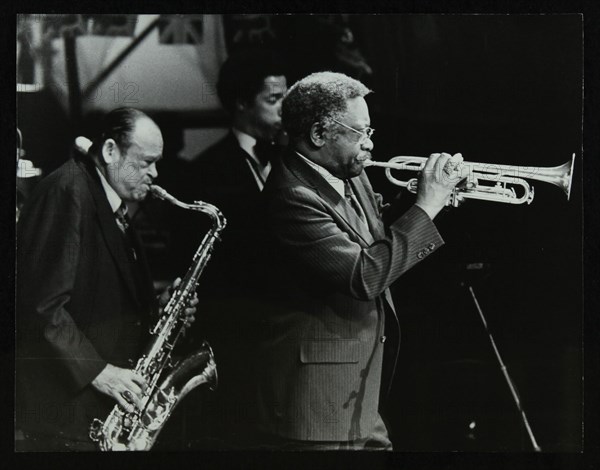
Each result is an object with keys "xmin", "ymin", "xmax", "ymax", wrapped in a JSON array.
[{"xmin": 89, "ymin": 185, "xmax": 227, "ymax": 451}]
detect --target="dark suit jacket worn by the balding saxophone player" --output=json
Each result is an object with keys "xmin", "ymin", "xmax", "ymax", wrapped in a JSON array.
[{"xmin": 16, "ymin": 158, "xmax": 156, "ymax": 440}]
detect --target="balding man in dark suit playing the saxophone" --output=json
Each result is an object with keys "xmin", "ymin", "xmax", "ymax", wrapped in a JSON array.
[{"xmin": 16, "ymin": 108, "xmax": 198, "ymax": 451}]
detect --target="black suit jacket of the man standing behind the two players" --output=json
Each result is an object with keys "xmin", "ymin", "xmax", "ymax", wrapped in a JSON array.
[{"xmin": 173, "ymin": 132, "xmax": 282, "ymax": 446}]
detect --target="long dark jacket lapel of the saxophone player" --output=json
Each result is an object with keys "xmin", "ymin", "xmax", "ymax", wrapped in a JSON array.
[{"xmin": 81, "ymin": 158, "xmax": 139, "ymax": 303}]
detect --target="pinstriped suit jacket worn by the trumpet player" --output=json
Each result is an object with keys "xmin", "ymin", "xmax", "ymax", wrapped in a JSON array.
[{"xmin": 257, "ymin": 152, "xmax": 443, "ymax": 441}]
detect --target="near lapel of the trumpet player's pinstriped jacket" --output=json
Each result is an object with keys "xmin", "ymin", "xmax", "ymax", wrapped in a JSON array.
[{"xmin": 286, "ymin": 152, "xmax": 375, "ymax": 245}]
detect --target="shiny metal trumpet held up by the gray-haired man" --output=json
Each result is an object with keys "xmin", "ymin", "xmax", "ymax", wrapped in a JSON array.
[{"xmin": 364, "ymin": 154, "xmax": 575, "ymax": 207}]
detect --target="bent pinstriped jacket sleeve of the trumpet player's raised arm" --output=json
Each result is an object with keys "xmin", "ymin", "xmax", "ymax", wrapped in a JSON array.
[{"xmin": 268, "ymin": 187, "xmax": 444, "ymax": 300}]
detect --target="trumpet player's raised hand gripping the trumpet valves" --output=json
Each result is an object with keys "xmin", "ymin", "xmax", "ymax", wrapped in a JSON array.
[{"xmin": 416, "ymin": 153, "xmax": 463, "ymax": 219}]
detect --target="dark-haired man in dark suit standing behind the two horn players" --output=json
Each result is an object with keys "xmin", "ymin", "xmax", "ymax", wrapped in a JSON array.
[{"xmin": 174, "ymin": 49, "xmax": 287, "ymax": 447}]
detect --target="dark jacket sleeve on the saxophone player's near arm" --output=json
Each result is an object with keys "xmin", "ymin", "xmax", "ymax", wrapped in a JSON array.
[{"xmin": 17, "ymin": 182, "xmax": 106, "ymax": 393}]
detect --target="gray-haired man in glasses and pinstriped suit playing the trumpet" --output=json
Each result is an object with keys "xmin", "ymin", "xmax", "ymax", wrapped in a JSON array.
[{"xmin": 257, "ymin": 72, "xmax": 462, "ymax": 450}]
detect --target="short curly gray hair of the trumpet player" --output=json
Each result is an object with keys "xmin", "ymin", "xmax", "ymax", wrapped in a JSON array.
[{"xmin": 282, "ymin": 72, "xmax": 371, "ymax": 142}]
